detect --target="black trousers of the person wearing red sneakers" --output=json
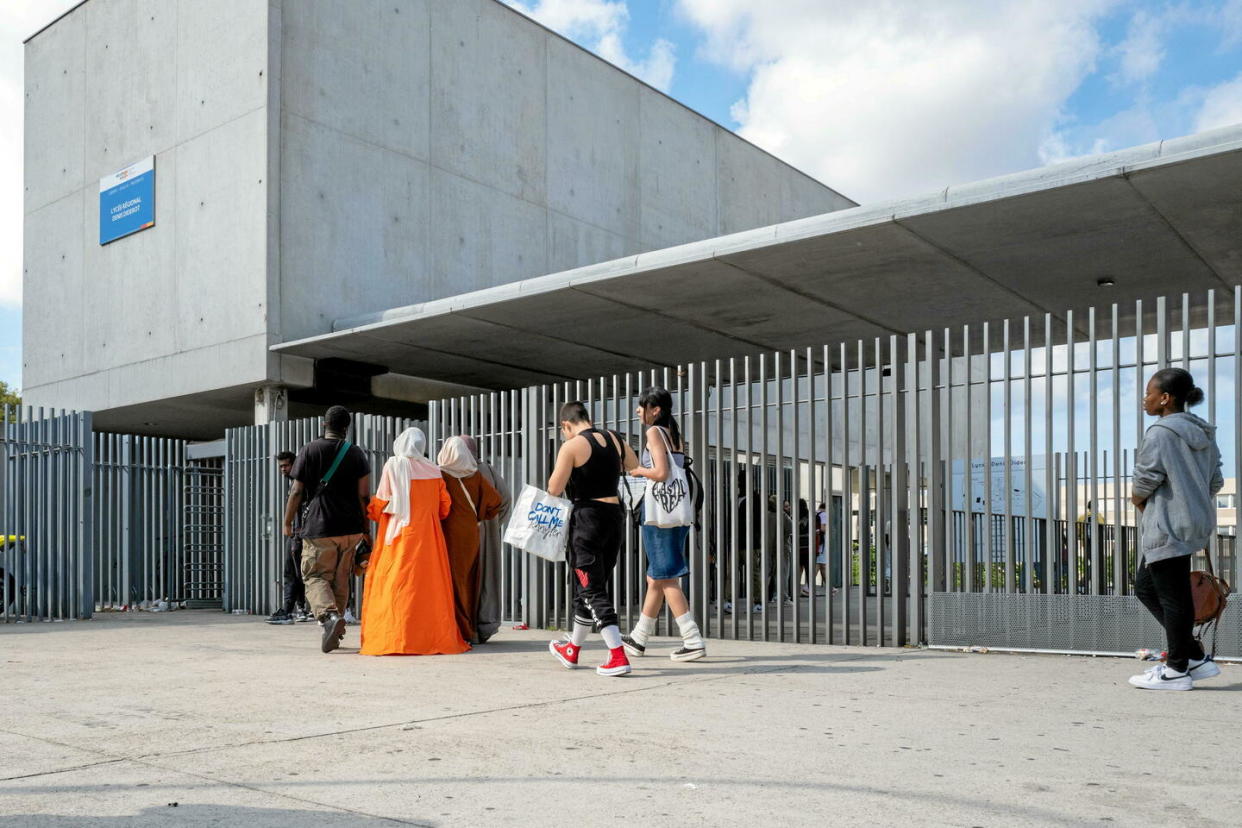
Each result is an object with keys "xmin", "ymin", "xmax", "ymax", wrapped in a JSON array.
[{"xmin": 566, "ymin": 500, "xmax": 625, "ymax": 629}]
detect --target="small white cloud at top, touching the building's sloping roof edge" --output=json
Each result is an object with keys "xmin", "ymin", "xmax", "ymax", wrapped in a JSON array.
[{"xmin": 504, "ymin": 0, "xmax": 677, "ymax": 92}]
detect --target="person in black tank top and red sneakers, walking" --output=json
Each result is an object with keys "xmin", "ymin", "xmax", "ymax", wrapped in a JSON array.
[{"xmin": 548, "ymin": 402, "xmax": 638, "ymax": 675}]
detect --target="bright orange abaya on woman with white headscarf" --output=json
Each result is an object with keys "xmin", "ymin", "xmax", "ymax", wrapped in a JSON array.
[{"xmin": 360, "ymin": 478, "xmax": 477, "ymax": 655}]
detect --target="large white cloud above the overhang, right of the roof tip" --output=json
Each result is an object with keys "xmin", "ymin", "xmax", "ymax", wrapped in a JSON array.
[{"xmin": 679, "ymin": 0, "xmax": 1113, "ymax": 201}]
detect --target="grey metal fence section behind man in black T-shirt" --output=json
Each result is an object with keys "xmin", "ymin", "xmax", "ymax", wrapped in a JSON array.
[{"xmin": 222, "ymin": 415, "xmax": 424, "ymax": 614}]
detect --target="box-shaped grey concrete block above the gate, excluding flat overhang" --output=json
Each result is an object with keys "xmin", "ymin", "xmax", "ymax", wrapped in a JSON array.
[{"xmin": 24, "ymin": 0, "xmax": 852, "ymax": 436}]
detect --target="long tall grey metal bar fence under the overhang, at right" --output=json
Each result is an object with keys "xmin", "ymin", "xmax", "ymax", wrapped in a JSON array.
[{"xmin": 431, "ymin": 288, "xmax": 1242, "ymax": 655}]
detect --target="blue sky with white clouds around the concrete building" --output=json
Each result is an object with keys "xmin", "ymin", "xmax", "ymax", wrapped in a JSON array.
[{"xmin": 0, "ymin": 0, "xmax": 1242, "ymax": 394}]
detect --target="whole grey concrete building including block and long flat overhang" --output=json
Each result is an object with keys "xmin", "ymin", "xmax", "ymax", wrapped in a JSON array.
[{"xmin": 24, "ymin": 0, "xmax": 1242, "ymax": 446}]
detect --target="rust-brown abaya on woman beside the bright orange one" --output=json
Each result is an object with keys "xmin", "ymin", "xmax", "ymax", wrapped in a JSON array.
[{"xmin": 441, "ymin": 472, "xmax": 502, "ymax": 642}]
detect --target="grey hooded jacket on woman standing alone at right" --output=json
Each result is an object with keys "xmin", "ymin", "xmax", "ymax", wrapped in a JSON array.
[{"xmin": 1134, "ymin": 413, "xmax": 1225, "ymax": 564}]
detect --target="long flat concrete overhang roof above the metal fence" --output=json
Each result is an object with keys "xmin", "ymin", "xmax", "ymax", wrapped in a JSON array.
[{"xmin": 272, "ymin": 125, "xmax": 1242, "ymax": 389}]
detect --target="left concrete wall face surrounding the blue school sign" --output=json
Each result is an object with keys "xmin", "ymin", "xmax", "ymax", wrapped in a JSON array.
[{"xmin": 22, "ymin": 0, "xmax": 279, "ymax": 422}]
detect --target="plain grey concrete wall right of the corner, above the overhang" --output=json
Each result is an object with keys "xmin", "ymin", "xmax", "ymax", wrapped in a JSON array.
[{"xmin": 278, "ymin": 0, "xmax": 851, "ymax": 340}]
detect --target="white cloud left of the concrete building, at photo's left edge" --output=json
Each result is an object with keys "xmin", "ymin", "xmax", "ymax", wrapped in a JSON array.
[{"xmin": 0, "ymin": 0, "xmax": 76, "ymax": 307}]
